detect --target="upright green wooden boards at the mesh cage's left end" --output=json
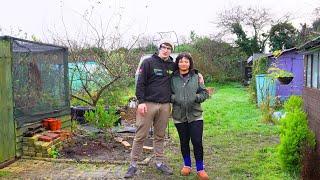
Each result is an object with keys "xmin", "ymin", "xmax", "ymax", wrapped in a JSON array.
[{"xmin": 0, "ymin": 40, "xmax": 16, "ymax": 164}]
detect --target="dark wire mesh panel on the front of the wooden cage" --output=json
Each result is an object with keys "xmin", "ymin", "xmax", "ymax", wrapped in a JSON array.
[{"xmin": 12, "ymin": 39, "xmax": 70, "ymax": 125}]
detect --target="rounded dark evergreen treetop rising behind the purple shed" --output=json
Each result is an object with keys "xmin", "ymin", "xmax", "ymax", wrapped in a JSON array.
[{"xmin": 269, "ymin": 22, "xmax": 297, "ymax": 51}]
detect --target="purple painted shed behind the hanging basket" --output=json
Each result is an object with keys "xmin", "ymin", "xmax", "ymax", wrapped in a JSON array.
[{"xmin": 268, "ymin": 48, "xmax": 304, "ymax": 100}]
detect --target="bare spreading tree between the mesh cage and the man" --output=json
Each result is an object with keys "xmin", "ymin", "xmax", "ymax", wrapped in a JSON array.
[{"xmin": 52, "ymin": 3, "xmax": 140, "ymax": 106}]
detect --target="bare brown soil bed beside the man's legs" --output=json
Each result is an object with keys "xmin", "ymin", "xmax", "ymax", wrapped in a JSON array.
[{"xmin": 59, "ymin": 108, "xmax": 165, "ymax": 161}]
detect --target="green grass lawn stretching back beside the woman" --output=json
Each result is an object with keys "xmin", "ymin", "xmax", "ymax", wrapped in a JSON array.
[{"xmin": 162, "ymin": 83, "xmax": 297, "ymax": 179}]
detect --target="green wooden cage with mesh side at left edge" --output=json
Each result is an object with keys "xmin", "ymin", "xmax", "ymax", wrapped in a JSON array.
[{"xmin": 0, "ymin": 36, "xmax": 71, "ymax": 165}]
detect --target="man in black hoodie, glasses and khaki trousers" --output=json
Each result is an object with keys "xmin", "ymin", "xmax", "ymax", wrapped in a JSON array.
[{"xmin": 125, "ymin": 40, "xmax": 175, "ymax": 178}]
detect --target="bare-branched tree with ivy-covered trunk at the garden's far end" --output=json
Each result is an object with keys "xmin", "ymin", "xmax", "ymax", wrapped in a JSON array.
[{"xmin": 217, "ymin": 6, "xmax": 271, "ymax": 55}]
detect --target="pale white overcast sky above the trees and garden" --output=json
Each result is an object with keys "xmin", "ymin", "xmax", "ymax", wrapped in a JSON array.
[{"xmin": 0, "ymin": 0, "xmax": 320, "ymax": 43}]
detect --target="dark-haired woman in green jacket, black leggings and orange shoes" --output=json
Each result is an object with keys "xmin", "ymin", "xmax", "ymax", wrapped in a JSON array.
[{"xmin": 171, "ymin": 53, "xmax": 209, "ymax": 179}]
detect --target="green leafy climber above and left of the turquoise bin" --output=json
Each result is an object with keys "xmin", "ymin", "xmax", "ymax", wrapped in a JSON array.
[{"xmin": 249, "ymin": 57, "xmax": 269, "ymax": 102}]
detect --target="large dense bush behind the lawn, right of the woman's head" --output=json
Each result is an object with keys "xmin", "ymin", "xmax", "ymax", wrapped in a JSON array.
[{"xmin": 192, "ymin": 37, "xmax": 245, "ymax": 83}]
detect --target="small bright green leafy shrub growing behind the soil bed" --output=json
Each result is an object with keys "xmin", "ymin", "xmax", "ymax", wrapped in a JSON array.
[{"xmin": 84, "ymin": 106, "xmax": 119, "ymax": 129}]
